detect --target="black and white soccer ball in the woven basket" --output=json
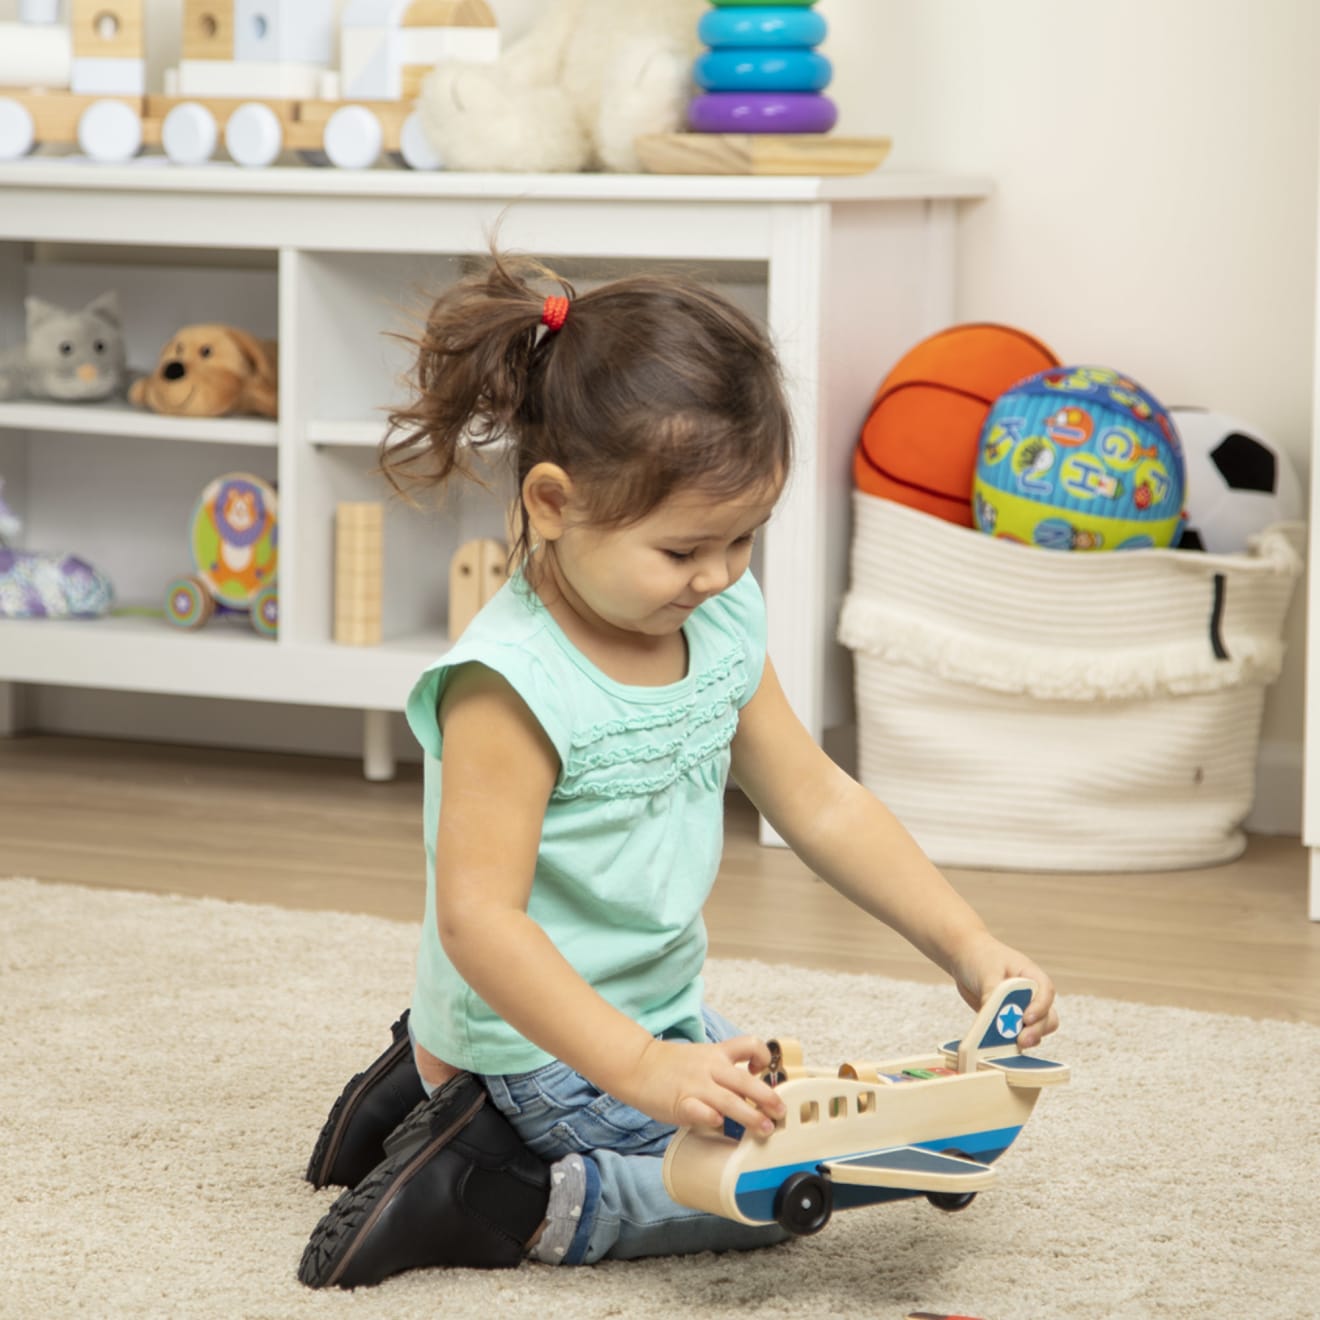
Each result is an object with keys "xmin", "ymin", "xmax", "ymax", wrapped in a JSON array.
[{"xmin": 1171, "ymin": 408, "xmax": 1302, "ymax": 554}]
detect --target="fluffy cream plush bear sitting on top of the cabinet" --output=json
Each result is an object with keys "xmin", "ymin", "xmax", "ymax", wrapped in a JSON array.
[{"xmin": 417, "ymin": 0, "xmax": 709, "ymax": 172}]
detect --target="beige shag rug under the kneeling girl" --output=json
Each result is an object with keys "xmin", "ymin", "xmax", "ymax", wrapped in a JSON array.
[{"xmin": 0, "ymin": 879, "xmax": 1320, "ymax": 1320}]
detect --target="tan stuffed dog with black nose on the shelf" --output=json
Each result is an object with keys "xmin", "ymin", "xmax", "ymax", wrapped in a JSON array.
[{"xmin": 128, "ymin": 325, "xmax": 279, "ymax": 417}]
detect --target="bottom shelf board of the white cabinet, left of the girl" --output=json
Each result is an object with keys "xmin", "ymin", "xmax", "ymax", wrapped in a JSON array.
[{"xmin": 0, "ymin": 615, "xmax": 449, "ymax": 710}]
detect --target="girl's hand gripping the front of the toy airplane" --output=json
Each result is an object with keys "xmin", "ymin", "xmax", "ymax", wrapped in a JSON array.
[{"xmin": 616, "ymin": 1036, "xmax": 784, "ymax": 1135}]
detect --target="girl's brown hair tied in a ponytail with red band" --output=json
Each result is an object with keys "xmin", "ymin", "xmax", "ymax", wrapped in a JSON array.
[{"xmin": 380, "ymin": 253, "xmax": 792, "ymax": 572}]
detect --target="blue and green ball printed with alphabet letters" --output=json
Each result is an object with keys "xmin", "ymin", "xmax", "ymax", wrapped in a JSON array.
[{"xmin": 972, "ymin": 367, "xmax": 1187, "ymax": 550}]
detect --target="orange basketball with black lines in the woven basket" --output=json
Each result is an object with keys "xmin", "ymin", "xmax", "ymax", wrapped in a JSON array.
[{"xmin": 853, "ymin": 323, "xmax": 1059, "ymax": 527}]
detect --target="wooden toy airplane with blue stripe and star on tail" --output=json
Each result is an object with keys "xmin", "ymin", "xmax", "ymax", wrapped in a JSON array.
[{"xmin": 664, "ymin": 978, "xmax": 1068, "ymax": 1234}]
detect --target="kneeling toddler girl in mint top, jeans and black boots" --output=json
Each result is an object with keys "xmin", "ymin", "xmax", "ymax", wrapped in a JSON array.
[{"xmin": 300, "ymin": 256, "xmax": 1057, "ymax": 1287}]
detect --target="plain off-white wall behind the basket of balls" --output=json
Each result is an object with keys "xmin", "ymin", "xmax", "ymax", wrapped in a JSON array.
[{"xmin": 821, "ymin": 0, "xmax": 1320, "ymax": 832}]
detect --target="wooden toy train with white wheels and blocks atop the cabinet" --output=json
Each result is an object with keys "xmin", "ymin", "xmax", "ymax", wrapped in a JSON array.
[{"xmin": 0, "ymin": 0, "xmax": 499, "ymax": 169}]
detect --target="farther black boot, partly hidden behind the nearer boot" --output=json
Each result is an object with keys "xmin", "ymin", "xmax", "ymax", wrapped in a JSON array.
[{"xmin": 306, "ymin": 1010, "xmax": 426, "ymax": 1187}]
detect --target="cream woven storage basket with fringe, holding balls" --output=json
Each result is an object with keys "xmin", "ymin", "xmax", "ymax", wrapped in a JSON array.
[{"xmin": 838, "ymin": 492, "xmax": 1302, "ymax": 871}]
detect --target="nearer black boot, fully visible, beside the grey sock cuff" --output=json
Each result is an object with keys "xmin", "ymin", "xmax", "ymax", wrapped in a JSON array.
[{"xmin": 298, "ymin": 1073, "xmax": 550, "ymax": 1288}]
